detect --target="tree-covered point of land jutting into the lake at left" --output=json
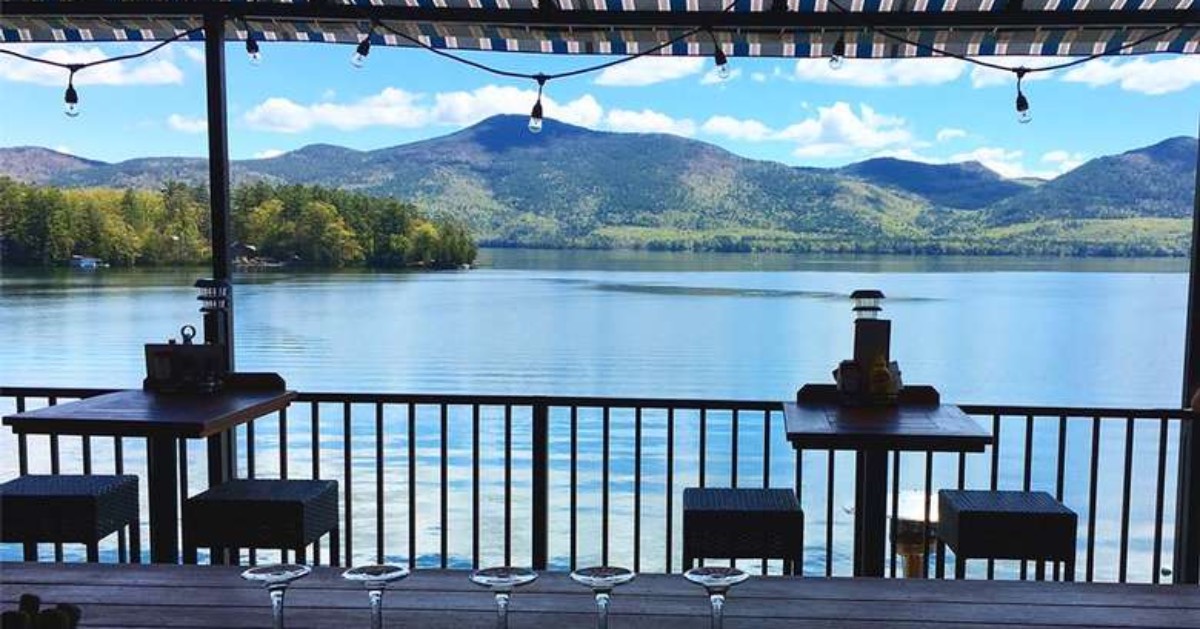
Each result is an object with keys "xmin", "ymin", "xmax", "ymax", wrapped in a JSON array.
[{"xmin": 0, "ymin": 178, "xmax": 476, "ymax": 268}]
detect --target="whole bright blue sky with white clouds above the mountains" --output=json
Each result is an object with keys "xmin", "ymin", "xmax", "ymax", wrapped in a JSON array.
[{"xmin": 0, "ymin": 42, "xmax": 1200, "ymax": 176}]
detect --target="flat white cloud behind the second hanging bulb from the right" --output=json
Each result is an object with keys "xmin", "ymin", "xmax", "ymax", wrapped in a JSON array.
[{"xmin": 792, "ymin": 58, "xmax": 965, "ymax": 88}]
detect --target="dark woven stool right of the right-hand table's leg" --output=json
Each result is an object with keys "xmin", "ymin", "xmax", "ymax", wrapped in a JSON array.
[{"xmin": 937, "ymin": 490, "xmax": 1079, "ymax": 581}]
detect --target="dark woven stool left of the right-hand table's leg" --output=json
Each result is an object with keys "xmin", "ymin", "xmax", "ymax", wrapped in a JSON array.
[{"xmin": 683, "ymin": 487, "xmax": 804, "ymax": 574}]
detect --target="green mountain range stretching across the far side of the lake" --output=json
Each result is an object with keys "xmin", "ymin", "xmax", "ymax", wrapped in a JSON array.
[{"xmin": 0, "ymin": 116, "xmax": 1196, "ymax": 254}]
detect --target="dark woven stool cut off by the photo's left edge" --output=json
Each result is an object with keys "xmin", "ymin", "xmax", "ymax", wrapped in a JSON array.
[{"xmin": 0, "ymin": 474, "xmax": 142, "ymax": 563}]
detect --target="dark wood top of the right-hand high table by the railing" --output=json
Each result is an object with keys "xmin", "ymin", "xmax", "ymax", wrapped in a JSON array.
[{"xmin": 784, "ymin": 402, "xmax": 991, "ymax": 453}]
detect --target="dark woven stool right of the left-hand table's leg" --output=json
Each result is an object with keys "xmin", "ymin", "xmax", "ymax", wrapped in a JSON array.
[{"xmin": 184, "ymin": 480, "xmax": 340, "ymax": 565}]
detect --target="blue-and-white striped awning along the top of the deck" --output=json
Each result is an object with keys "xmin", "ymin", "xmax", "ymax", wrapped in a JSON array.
[{"xmin": 0, "ymin": 0, "xmax": 1200, "ymax": 58}]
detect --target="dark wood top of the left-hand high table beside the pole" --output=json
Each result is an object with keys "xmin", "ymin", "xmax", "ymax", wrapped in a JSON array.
[{"xmin": 4, "ymin": 389, "xmax": 296, "ymax": 438}]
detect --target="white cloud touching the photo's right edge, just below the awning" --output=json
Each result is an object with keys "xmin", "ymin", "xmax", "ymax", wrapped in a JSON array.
[{"xmin": 1062, "ymin": 55, "xmax": 1200, "ymax": 96}]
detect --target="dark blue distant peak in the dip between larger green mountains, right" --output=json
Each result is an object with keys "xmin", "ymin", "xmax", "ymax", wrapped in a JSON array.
[{"xmin": 839, "ymin": 157, "xmax": 1028, "ymax": 210}]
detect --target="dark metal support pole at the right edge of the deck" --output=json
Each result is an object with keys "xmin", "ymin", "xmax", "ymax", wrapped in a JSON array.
[{"xmin": 1175, "ymin": 121, "xmax": 1200, "ymax": 583}]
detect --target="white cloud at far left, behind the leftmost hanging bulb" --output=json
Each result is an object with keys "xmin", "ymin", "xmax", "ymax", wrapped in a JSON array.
[{"xmin": 0, "ymin": 46, "xmax": 184, "ymax": 88}]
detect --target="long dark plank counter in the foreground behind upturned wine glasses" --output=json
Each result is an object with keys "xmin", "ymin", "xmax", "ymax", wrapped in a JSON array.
[{"xmin": 0, "ymin": 563, "xmax": 1200, "ymax": 629}]
